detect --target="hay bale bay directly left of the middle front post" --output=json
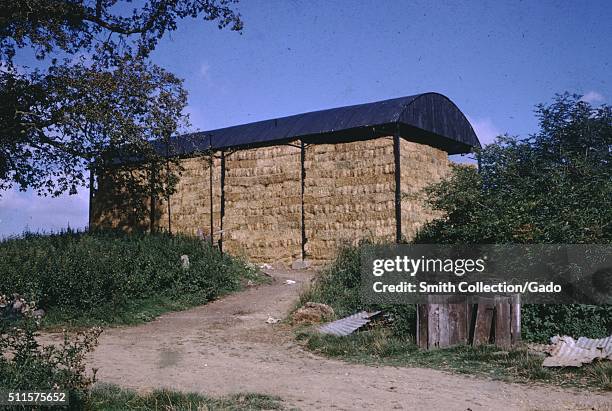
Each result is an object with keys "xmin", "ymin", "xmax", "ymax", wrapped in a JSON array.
[{"xmin": 223, "ymin": 145, "xmax": 302, "ymax": 265}]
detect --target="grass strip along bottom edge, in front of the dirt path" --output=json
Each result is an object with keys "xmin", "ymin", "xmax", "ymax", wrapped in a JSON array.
[{"xmin": 89, "ymin": 384, "xmax": 284, "ymax": 411}]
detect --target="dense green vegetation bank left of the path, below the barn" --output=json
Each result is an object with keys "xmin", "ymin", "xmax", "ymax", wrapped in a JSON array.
[{"xmin": 0, "ymin": 231, "xmax": 257, "ymax": 324}]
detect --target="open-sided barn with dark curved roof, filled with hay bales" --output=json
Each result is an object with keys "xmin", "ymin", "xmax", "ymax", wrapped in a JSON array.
[{"xmin": 90, "ymin": 93, "xmax": 480, "ymax": 266}]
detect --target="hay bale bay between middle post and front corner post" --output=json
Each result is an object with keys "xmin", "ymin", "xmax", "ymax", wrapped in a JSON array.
[{"xmin": 304, "ymin": 138, "xmax": 395, "ymax": 265}]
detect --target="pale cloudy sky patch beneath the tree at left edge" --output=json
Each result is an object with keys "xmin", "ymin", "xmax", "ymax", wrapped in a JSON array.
[{"xmin": 0, "ymin": 188, "xmax": 89, "ymax": 238}]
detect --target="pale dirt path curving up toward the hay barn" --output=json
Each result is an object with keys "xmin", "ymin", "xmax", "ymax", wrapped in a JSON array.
[{"xmin": 92, "ymin": 271, "xmax": 612, "ymax": 410}]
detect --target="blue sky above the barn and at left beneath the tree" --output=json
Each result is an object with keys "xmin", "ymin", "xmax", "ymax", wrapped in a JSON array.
[{"xmin": 0, "ymin": 0, "xmax": 612, "ymax": 236}]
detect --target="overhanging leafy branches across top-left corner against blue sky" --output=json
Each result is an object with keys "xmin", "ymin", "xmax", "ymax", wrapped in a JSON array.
[{"xmin": 0, "ymin": 0, "xmax": 243, "ymax": 59}]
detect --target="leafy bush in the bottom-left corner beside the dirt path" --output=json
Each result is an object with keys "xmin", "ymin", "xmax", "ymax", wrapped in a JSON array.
[{"xmin": 0, "ymin": 296, "xmax": 102, "ymax": 409}]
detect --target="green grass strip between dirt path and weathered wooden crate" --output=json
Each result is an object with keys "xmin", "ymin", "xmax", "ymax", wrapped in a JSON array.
[{"xmin": 297, "ymin": 327, "xmax": 612, "ymax": 391}]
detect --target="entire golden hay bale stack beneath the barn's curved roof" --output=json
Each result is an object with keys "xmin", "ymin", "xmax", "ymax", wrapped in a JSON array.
[{"xmin": 94, "ymin": 137, "xmax": 449, "ymax": 266}]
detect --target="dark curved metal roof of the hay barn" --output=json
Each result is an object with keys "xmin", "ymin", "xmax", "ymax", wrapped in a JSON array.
[{"xmin": 158, "ymin": 93, "xmax": 480, "ymax": 155}]
